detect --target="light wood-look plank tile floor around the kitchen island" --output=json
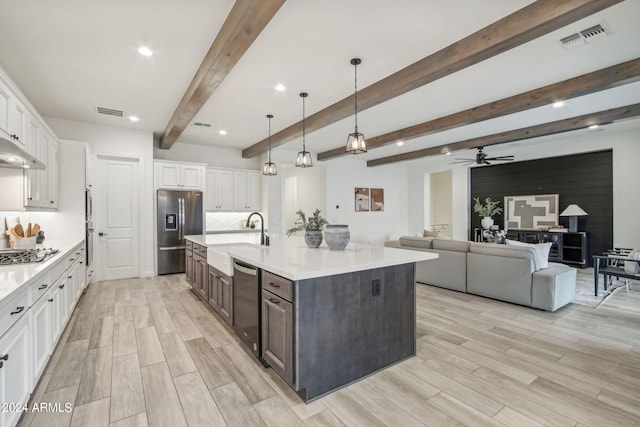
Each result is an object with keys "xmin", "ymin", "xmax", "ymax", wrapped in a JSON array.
[{"xmin": 20, "ymin": 275, "xmax": 640, "ymax": 427}]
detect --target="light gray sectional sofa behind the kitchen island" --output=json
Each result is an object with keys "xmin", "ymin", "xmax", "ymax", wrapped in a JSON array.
[{"xmin": 385, "ymin": 236, "xmax": 576, "ymax": 311}]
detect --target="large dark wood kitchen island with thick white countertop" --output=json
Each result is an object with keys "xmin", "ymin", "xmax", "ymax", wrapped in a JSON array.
[{"xmin": 184, "ymin": 238, "xmax": 437, "ymax": 402}]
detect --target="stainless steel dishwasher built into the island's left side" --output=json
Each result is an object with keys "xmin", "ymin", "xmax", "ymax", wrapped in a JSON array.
[{"xmin": 233, "ymin": 260, "xmax": 267, "ymax": 366}]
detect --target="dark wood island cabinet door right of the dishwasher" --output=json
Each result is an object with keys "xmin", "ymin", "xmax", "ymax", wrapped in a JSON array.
[{"xmin": 262, "ymin": 290, "xmax": 293, "ymax": 384}]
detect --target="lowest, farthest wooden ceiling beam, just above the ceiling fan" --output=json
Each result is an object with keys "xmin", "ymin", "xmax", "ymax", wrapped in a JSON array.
[{"xmin": 367, "ymin": 104, "xmax": 640, "ymax": 166}]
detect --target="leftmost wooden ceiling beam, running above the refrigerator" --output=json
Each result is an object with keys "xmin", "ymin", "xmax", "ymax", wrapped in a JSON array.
[{"xmin": 159, "ymin": 0, "xmax": 285, "ymax": 149}]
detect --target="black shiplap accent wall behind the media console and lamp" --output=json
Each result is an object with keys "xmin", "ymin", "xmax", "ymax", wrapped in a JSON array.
[{"xmin": 469, "ymin": 150, "xmax": 613, "ymax": 264}]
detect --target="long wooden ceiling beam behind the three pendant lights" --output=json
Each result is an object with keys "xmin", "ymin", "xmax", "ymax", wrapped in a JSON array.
[{"xmin": 242, "ymin": 0, "xmax": 622, "ymax": 158}]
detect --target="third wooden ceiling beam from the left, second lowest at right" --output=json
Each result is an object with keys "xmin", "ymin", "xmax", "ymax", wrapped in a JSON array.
[{"xmin": 318, "ymin": 58, "xmax": 640, "ymax": 160}]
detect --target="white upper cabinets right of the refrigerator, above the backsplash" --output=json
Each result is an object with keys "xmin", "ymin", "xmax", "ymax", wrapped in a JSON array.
[{"xmin": 205, "ymin": 168, "xmax": 260, "ymax": 211}]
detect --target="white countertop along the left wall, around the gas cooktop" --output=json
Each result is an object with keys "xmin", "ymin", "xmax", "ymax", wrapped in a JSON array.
[{"xmin": 0, "ymin": 239, "xmax": 81, "ymax": 301}]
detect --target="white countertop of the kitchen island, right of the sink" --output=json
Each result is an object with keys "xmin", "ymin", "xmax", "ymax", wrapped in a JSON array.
[{"xmin": 225, "ymin": 237, "xmax": 438, "ymax": 281}]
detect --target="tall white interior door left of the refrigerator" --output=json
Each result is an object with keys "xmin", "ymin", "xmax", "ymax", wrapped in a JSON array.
[{"xmin": 94, "ymin": 155, "xmax": 140, "ymax": 280}]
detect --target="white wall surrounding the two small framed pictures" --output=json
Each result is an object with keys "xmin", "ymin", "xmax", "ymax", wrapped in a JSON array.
[{"xmin": 322, "ymin": 156, "xmax": 408, "ymax": 245}]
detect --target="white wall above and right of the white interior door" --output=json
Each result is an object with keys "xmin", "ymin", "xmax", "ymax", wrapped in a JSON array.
[{"xmin": 45, "ymin": 118, "xmax": 155, "ymax": 281}]
